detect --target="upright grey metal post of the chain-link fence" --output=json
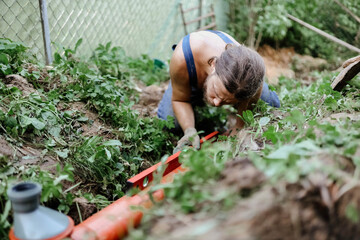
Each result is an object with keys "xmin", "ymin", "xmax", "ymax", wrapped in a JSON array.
[{"xmin": 39, "ymin": 0, "xmax": 52, "ymax": 65}]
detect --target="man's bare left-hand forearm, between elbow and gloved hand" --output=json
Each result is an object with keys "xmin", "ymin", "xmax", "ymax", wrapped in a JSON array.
[{"xmin": 172, "ymin": 101, "xmax": 195, "ymax": 132}]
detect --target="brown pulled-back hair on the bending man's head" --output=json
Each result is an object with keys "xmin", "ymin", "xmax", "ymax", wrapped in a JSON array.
[{"xmin": 215, "ymin": 44, "xmax": 265, "ymax": 100}]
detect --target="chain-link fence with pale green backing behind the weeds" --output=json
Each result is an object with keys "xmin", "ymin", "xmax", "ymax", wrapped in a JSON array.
[{"xmin": 0, "ymin": 0, "xmax": 226, "ymax": 60}]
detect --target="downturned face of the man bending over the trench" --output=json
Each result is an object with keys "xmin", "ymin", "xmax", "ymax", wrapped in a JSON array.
[{"xmin": 204, "ymin": 72, "xmax": 237, "ymax": 107}]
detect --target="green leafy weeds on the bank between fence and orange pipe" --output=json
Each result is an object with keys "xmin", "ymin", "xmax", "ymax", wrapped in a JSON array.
[{"xmin": 0, "ymin": 39, "xmax": 173, "ymax": 236}]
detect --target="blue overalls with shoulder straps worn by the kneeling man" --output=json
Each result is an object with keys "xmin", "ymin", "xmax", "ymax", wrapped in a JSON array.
[{"xmin": 157, "ymin": 30, "xmax": 280, "ymax": 128}]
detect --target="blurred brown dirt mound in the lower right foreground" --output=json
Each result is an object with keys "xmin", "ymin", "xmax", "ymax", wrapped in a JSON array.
[{"xmin": 136, "ymin": 148, "xmax": 360, "ymax": 240}]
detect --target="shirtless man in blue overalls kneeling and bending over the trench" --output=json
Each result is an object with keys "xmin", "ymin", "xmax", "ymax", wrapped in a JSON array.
[{"xmin": 158, "ymin": 31, "xmax": 280, "ymax": 153}]
